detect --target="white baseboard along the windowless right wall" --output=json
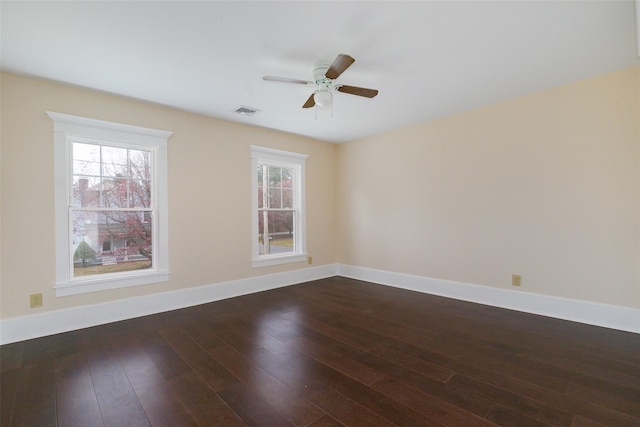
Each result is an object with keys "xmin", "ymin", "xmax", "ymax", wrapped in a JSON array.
[{"xmin": 337, "ymin": 264, "xmax": 640, "ymax": 333}]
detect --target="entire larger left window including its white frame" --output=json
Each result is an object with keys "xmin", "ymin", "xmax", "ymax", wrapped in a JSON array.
[{"xmin": 47, "ymin": 112, "xmax": 171, "ymax": 296}]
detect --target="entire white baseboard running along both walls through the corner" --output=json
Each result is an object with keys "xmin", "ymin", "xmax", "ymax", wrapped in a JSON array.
[{"xmin": 0, "ymin": 264, "xmax": 640, "ymax": 344}]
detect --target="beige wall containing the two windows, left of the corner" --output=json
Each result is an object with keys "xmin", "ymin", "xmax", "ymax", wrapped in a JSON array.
[{"xmin": 0, "ymin": 73, "xmax": 337, "ymax": 318}]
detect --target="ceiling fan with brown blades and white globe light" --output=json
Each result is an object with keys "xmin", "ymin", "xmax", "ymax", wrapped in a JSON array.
[{"xmin": 262, "ymin": 54, "xmax": 378, "ymax": 108}]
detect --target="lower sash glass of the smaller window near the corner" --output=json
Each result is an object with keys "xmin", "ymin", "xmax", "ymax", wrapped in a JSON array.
[{"xmin": 258, "ymin": 211, "xmax": 295, "ymax": 255}]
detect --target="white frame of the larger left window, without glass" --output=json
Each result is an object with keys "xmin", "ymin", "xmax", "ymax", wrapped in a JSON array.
[{"xmin": 47, "ymin": 111, "xmax": 172, "ymax": 296}]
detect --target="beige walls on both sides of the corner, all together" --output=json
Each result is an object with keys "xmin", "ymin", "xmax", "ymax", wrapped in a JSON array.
[{"xmin": 0, "ymin": 68, "xmax": 640, "ymax": 319}]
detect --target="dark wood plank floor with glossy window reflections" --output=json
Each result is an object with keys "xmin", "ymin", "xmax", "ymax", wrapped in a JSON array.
[{"xmin": 0, "ymin": 277, "xmax": 640, "ymax": 427}]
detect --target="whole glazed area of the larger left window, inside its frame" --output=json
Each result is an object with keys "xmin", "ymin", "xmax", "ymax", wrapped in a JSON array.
[{"xmin": 69, "ymin": 139, "xmax": 156, "ymax": 277}]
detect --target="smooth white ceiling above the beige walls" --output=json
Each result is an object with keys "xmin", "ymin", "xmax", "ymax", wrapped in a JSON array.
[{"xmin": 0, "ymin": 1, "xmax": 638, "ymax": 142}]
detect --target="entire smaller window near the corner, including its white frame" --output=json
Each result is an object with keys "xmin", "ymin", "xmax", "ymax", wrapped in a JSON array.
[{"xmin": 251, "ymin": 145, "xmax": 308, "ymax": 267}]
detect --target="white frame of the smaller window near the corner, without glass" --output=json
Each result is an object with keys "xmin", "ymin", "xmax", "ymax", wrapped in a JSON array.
[{"xmin": 250, "ymin": 145, "xmax": 309, "ymax": 267}]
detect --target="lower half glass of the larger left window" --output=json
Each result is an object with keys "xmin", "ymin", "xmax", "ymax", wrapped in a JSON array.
[{"xmin": 71, "ymin": 210, "xmax": 153, "ymax": 277}]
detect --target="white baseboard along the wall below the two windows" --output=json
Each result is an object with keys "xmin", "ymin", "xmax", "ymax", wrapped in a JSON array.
[{"xmin": 0, "ymin": 264, "xmax": 336, "ymax": 344}]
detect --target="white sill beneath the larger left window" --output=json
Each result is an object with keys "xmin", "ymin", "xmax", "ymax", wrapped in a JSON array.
[{"xmin": 54, "ymin": 270, "xmax": 169, "ymax": 297}]
